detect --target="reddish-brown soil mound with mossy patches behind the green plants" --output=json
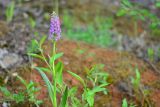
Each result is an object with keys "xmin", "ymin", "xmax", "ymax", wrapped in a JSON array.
[{"xmin": 0, "ymin": 40, "xmax": 160, "ymax": 107}]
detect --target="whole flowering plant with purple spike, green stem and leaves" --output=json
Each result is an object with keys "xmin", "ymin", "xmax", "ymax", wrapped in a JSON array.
[{"xmin": 28, "ymin": 12, "xmax": 68, "ymax": 107}]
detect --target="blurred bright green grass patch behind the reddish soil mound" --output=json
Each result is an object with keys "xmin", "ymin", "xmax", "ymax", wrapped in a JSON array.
[{"xmin": 62, "ymin": 12, "xmax": 114, "ymax": 47}]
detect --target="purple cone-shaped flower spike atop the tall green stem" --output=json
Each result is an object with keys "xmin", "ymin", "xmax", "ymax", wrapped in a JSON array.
[{"xmin": 48, "ymin": 12, "xmax": 61, "ymax": 41}]
